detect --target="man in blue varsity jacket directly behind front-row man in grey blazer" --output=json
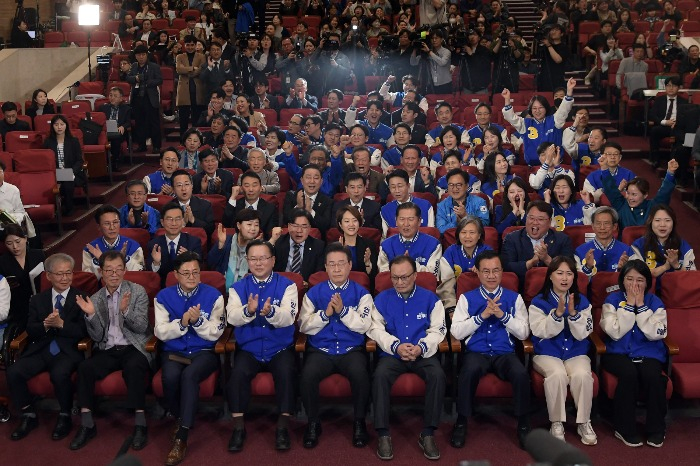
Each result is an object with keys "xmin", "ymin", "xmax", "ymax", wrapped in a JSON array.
[{"xmin": 82, "ymin": 204, "xmax": 144, "ymax": 279}]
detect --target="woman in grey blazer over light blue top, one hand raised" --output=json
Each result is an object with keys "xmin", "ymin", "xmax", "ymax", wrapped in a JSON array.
[{"xmin": 207, "ymin": 209, "xmax": 261, "ymax": 288}]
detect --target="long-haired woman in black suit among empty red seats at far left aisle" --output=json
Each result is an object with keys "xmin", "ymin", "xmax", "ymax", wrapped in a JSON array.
[{"xmin": 44, "ymin": 114, "xmax": 85, "ymax": 215}]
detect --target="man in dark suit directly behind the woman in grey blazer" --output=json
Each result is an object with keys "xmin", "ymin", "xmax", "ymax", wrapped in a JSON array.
[{"xmin": 222, "ymin": 171, "xmax": 279, "ymax": 239}]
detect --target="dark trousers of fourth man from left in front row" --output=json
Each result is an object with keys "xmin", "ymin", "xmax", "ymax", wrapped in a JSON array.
[{"xmin": 226, "ymin": 347, "xmax": 296, "ymax": 413}]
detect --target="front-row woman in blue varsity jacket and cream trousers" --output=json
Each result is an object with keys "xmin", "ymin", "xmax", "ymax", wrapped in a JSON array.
[{"xmin": 528, "ymin": 256, "xmax": 598, "ymax": 445}]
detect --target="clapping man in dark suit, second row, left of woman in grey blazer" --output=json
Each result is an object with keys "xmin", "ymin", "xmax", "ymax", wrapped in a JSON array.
[{"xmin": 146, "ymin": 201, "xmax": 202, "ymax": 287}]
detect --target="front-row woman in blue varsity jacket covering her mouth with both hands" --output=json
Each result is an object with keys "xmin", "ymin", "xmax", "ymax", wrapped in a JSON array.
[{"xmin": 600, "ymin": 259, "xmax": 668, "ymax": 448}]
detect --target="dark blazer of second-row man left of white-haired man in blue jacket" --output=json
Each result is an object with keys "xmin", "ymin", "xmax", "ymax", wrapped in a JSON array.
[{"xmin": 501, "ymin": 228, "xmax": 574, "ymax": 289}]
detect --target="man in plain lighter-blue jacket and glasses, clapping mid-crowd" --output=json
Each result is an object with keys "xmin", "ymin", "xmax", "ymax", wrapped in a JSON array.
[{"xmin": 435, "ymin": 168, "xmax": 490, "ymax": 234}]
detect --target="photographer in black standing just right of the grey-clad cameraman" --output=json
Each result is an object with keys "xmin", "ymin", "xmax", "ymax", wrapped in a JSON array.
[{"xmin": 452, "ymin": 29, "xmax": 493, "ymax": 94}]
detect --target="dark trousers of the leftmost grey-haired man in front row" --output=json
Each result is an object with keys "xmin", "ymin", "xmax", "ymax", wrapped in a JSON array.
[{"xmin": 7, "ymin": 346, "xmax": 81, "ymax": 413}]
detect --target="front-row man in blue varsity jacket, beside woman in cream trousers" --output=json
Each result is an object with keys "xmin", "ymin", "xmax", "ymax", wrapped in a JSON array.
[{"xmin": 450, "ymin": 251, "xmax": 530, "ymax": 448}]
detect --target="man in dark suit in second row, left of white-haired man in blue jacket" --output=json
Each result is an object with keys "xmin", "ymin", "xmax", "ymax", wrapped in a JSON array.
[{"xmin": 501, "ymin": 201, "xmax": 574, "ymax": 289}]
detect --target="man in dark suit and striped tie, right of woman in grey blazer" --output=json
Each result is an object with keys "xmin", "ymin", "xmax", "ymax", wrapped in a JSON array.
[{"xmin": 274, "ymin": 210, "xmax": 330, "ymax": 281}]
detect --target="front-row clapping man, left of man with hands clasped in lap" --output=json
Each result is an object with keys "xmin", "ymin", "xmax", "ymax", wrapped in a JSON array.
[{"xmin": 299, "ymin": 243, "xmax": 374, "ymax": 448}]
